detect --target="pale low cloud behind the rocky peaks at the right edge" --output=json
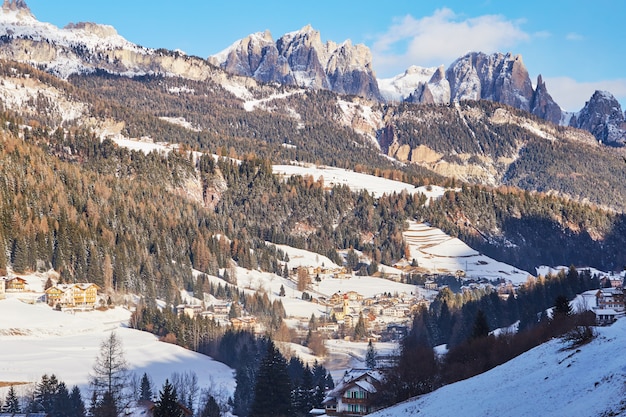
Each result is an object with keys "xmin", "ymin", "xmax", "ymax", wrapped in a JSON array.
[{"xmin": 544, "ymin": 77, "xmax": 626, "ymax": 111}]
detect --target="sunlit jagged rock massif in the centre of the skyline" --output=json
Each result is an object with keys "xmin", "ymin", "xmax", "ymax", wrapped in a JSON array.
[{"xmin": 209, "ymin": 26, "xmax": 381, "ymax": 100}]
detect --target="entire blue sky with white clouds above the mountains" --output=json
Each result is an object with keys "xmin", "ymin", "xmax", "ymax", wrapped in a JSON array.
[{"xmin": 27, "ymin": 0, "xmax": 626, "ymax": 111}]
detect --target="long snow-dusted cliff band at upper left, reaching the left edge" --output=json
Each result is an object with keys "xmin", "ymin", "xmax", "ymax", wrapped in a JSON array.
[{"xmin": 0, "ymin": 0, "xmax": 224, "ymax": 80}]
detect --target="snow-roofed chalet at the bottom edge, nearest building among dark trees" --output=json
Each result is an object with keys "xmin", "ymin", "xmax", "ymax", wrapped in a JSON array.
[{"xmin": 323, "ymin": 369, "xmax": 383, "ymax": 416}]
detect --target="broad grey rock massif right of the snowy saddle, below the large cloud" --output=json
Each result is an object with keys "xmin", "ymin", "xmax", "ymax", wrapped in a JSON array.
[{"xmin": 446, "ymin": 52, "xmax": 534, "ymax": 111}]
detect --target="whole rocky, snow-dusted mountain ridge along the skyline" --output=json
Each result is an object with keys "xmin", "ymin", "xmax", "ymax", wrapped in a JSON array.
[{"xmin": 0, "ymin": 0, "xmax": 626, "ymax": 146}]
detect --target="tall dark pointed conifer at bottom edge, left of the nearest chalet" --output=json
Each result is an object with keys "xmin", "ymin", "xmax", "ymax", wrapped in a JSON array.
[{"xmin": 250, "ymin": 341, "xmax": 293, "ymax": 417}]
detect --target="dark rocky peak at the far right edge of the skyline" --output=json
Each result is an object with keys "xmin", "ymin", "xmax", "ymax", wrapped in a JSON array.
[{"xmin": 570, "ymin": 91, "xmax": 626, "ymax": 145}]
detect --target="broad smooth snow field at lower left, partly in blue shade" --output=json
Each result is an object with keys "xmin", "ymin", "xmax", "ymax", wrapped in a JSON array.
[{"xmin": 0, "ymin": 294, "xmax": 235, "ymax": 398}]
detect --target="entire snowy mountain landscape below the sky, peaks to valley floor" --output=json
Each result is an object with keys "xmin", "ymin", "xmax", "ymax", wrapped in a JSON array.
[{"xmin": 0, "ymin": 0, "xmax": 626, "ymax": 417}]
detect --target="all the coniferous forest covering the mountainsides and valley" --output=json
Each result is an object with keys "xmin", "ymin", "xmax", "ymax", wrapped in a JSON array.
[{"xmin": 0, "ymin": 52, "xmax": 626, "ymax": 417}]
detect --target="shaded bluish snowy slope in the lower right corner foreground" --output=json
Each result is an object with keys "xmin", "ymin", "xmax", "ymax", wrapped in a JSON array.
[{"xmin": 371, "ymin": 319, "xmax": 626, "ymax": 417}]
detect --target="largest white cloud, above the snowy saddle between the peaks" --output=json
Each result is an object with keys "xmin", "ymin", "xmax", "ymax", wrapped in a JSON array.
[{"xmin": 372, "ymin": 8, "xmax": 531, "ymax": 76}]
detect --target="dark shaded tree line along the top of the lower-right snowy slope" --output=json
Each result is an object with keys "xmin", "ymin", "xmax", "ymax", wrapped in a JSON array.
[{"xmin": 376, "ymin": 267, "xmax": 599, "ymax": 405}]
